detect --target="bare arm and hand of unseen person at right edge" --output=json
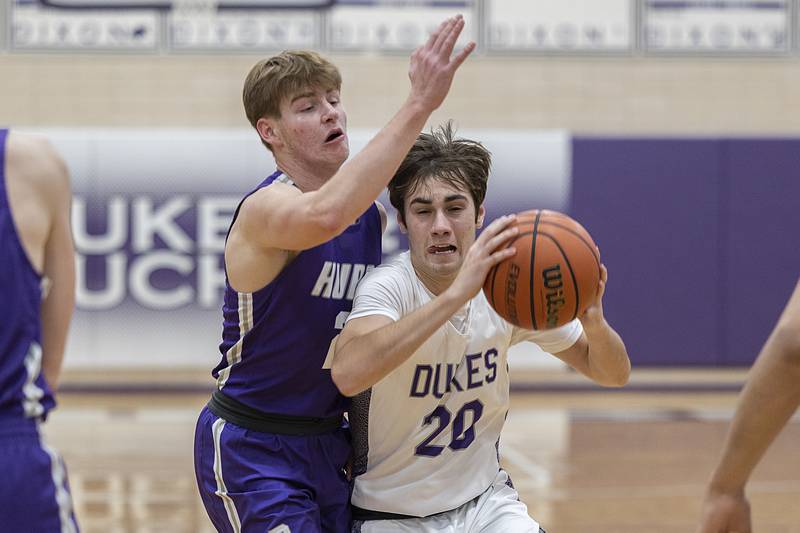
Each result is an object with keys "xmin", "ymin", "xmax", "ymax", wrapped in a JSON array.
[{"xmin": 698, "ymin": 281, "xmax": 800, "ymax": 533}]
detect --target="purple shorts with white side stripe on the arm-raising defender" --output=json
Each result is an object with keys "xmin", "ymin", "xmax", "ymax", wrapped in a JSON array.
[{"xmin": 194, "ymin": 407, "xmax": 351, "ymax": 533}]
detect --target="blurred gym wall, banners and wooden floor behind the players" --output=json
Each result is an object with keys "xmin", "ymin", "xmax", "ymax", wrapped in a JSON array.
[{"xmin": 0, "ymin": 0, "xmax": 800, "ymax": 533}]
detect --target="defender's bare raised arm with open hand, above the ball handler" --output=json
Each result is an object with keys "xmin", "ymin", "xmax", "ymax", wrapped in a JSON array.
[{"xmin": 237, "ymin": 16, "xmax": 475, "ymax": 250}]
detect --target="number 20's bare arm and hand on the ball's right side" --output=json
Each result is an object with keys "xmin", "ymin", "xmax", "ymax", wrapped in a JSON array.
[{"xmin": 553, "ymin": 265, "xmax": 631, "ymax": 387}]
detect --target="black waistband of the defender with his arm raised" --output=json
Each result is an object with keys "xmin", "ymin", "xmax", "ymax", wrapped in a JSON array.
[{"xmin": 208, "ymin": 390, "xmax": 342, "ymax": 435}]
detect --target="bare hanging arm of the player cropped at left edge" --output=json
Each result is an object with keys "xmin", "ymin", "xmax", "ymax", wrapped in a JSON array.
[{"xmin": 40, "ymin": 144, "xmax": 75, "ymax": 391}]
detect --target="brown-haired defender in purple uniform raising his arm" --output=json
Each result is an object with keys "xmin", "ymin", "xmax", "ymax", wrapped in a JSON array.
[{"xmin": 195, "ymin": 16, "xmax": 474, "ymax": 533}]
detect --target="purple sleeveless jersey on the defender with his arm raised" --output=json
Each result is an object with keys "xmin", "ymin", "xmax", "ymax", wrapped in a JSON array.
[{"xmin": 208, "ymin": 171, "xmax": 381, "ymax": 417}]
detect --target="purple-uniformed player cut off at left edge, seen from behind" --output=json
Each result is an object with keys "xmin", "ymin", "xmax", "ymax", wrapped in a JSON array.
[{"xmin": 0, "ymin": 129, "xmax": 78, "ymax": 533}]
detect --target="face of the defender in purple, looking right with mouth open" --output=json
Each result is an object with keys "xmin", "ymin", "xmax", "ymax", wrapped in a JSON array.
[{"xmin": 273, "ymin": 88, "xmax": 350, "ymax": 172}]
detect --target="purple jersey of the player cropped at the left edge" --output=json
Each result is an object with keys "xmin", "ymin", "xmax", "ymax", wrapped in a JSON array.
[{"xmin": 0, "ymin": 129, "xmax": 55, "ymax": 423}]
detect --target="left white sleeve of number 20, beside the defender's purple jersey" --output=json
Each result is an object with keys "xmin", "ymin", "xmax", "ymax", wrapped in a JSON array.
[{"xmin": 347, "ymin": 260, "xmax": 412, "ymax": 322}]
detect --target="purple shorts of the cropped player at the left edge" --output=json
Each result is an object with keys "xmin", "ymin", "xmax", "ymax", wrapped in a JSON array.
[{"xmin": 0, "ymin": 419, "xmax": 78, "ymax": 533}]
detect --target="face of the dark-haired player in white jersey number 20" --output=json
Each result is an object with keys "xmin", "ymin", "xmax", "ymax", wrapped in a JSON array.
[{"xmin": 400, "ymin": 178, "xmax": 484, "ymax": 284}]
